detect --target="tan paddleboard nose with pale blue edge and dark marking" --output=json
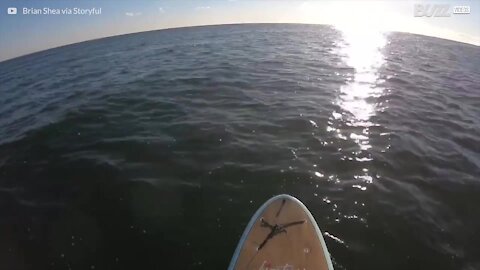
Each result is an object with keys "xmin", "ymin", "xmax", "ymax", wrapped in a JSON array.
[{"xmin": 228, "ymin": 195, "xmax": 333, "ymax": 270}]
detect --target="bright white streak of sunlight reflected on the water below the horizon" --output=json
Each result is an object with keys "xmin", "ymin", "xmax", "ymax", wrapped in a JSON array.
[{"xmin": 327, "ymin": 28, "xmax": 386, "ymax": 191}]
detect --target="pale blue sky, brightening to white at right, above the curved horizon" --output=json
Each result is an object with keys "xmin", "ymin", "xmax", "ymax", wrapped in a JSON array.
[{"xmin": 0, "ymin": 0, "xmax": 480, "ymax": 61}]
